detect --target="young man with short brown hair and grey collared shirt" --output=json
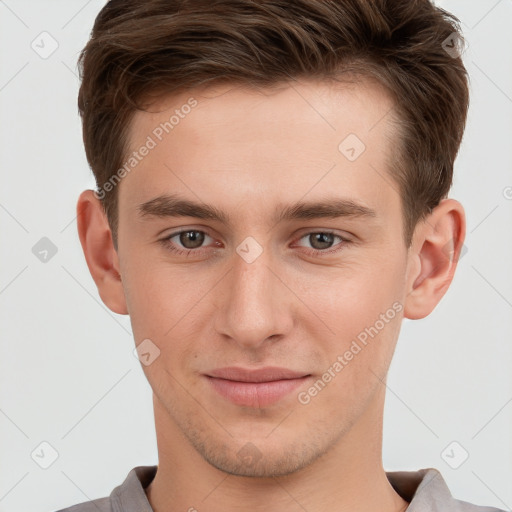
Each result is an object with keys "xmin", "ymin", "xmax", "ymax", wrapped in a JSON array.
[{"xmin": 59, "ymin": 0, "xmax": 504, "ymax": 512}]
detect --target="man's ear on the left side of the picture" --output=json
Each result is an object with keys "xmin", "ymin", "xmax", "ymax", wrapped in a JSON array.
[{"xmin": 76, "ymin": 190, "xmax": 128, "ymax": 315}]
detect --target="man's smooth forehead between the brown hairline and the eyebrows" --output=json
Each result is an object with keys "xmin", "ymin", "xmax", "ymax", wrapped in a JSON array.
[{"xmin": 120, "ymin": 77, "xmax": 397, "ymax": 224}]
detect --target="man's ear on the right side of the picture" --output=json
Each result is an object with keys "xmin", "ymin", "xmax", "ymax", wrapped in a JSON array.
[{"xmin": 404, "ymin": 199, "xmax": 466, "ymax": 320}]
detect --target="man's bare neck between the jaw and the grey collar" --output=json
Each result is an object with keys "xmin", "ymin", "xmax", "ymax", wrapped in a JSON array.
[{"xmin": 146, "ymin": 393, "xmax": 408, "ymax": 512}]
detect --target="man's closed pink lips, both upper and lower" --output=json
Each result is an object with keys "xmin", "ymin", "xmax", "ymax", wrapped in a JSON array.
[{"xmin": 205, "ymin": 367, "xmax": 311, "ymax": 408}]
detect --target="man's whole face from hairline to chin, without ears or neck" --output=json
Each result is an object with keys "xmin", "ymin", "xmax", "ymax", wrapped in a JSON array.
[{"xmin": 118, "ymin": 81, "xmax": 408, "ymax": 476}]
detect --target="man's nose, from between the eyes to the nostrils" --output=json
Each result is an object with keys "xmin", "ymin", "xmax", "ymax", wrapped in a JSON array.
[{"xmin": 215, "ymin": 242, "xmax": 297, "ymax": 350}]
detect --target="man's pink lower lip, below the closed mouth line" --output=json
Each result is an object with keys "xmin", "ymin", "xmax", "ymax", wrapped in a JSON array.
[{"xmin": 206, "ymin": 375, "xmax": 309, "ymax": 408}]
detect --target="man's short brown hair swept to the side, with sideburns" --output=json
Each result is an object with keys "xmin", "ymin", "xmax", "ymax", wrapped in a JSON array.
[{"xmin": 78, "ymin": 0, "xmax": 469, "ymax": 249}]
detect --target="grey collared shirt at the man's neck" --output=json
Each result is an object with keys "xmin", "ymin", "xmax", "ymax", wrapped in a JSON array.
[{"xmin": 57, "ymin": 466, "xmax": 505, "ymax": 512}]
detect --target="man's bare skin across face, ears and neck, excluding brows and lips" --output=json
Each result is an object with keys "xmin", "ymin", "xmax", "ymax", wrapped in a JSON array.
[{"xmin": 77, "ymin": 77, "xmax": 465, "ymax": 512}]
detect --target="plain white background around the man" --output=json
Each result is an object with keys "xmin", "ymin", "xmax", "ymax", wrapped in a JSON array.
[{"xmin": 0, "ymin": 0, "xmax": 512, "ymax": 512}]
